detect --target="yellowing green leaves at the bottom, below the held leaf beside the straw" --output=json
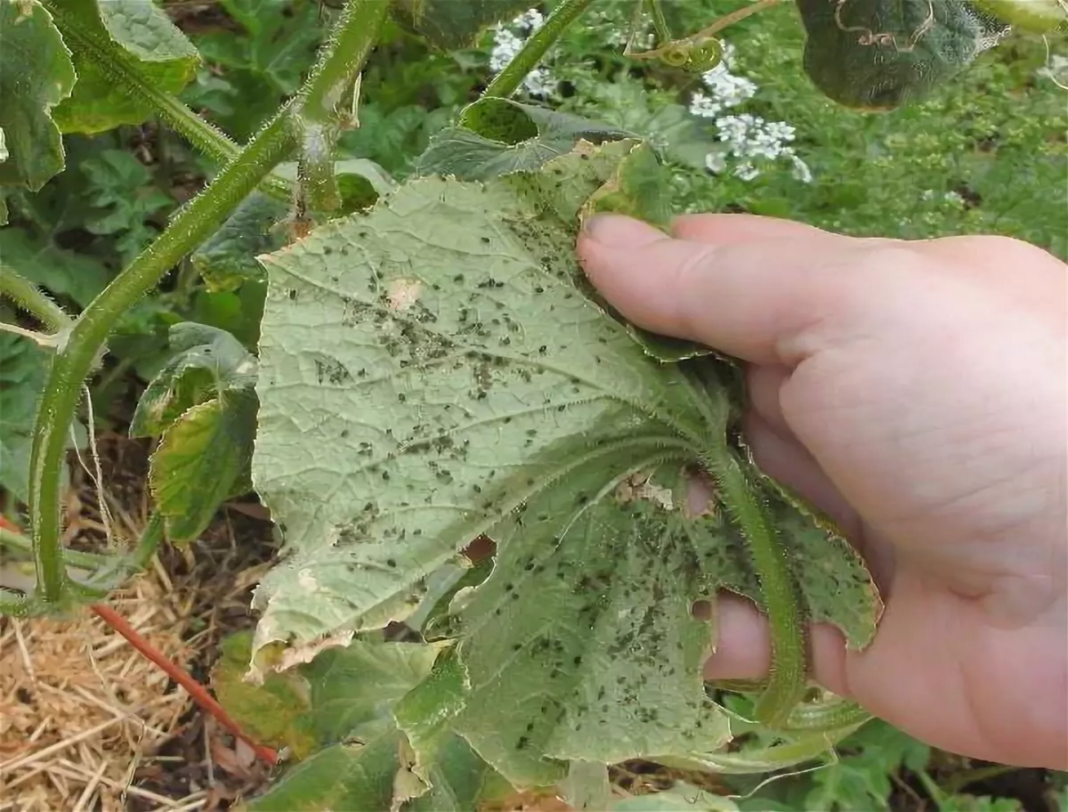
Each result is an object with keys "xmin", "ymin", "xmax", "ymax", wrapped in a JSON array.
[{"xmin": 213, "ymin": 635, "xmax": 503, "ymax": 812}]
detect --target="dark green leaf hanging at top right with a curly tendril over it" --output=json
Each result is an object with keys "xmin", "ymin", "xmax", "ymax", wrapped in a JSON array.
[{"xmin": 798, "ymin": 0, "xmax": 1008, "ymax": 110}]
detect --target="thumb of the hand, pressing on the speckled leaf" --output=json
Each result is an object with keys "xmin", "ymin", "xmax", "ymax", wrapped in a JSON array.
[{"xmin": 578, "ymin": 215, "xmax": 863, "ymax": 366}]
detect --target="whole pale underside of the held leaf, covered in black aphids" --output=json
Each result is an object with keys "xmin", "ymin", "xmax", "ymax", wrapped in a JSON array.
[{"xmin": 252, "ymin": 140, "xmax": 879, "ymax": 785}]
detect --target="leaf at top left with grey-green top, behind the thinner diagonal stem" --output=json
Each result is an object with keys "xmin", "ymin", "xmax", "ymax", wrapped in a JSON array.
[{"xmin": 47, "ymin": 0, "xmax": 200, "ymax": 132}]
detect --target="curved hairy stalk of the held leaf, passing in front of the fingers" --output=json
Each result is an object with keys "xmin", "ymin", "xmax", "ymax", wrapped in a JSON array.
[{"xmin": 707, "ymin": 448, "xmax": 807, "ymax": 727}]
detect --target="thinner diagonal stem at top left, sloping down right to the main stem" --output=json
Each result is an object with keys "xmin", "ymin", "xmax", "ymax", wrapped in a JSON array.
[{"xmin": 45, "ymin": 0, "xmax": 293, "ymax": 202}]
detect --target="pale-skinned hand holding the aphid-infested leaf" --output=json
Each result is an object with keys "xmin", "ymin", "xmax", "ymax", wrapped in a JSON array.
[{"xmin": 578, "ymin": 215, "xmax": 1068, "ymax": 770}]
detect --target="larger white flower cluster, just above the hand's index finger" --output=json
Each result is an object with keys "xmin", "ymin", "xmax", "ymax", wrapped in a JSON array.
[{"xmin": 690, "ymin": 43, "xmax": 812, "ymax": 183}]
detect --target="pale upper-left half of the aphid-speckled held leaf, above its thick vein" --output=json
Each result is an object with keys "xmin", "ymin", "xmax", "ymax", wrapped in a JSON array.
[{"xmin": 253, "ymin": 142, "xmax": 703, "ymax": 647}]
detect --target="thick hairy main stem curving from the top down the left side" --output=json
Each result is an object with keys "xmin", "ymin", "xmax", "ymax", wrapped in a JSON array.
[{"xmin": 29, "ymin": 0, "xmax": 387, "ymax": 604}]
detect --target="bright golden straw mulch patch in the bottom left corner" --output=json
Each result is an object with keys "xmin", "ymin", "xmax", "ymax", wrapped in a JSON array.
[{"xmin": 0, "ymin": 571, "xmax": 204, "ymax": 812}]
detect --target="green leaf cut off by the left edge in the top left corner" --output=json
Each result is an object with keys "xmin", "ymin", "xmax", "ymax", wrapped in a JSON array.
[{"xmin": 0, "ymin": 0, "xmax": 75, "ymax": 191}]
